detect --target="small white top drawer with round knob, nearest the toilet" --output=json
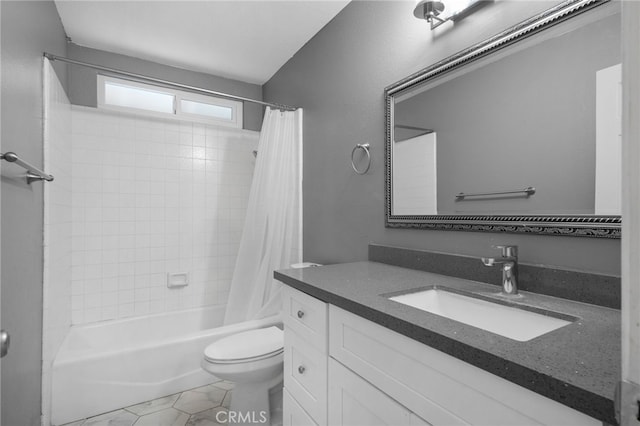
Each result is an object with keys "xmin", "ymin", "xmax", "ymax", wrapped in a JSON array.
[{"xmin": 283, "ymin": 286, "xmax": 328, "ymax": 354}]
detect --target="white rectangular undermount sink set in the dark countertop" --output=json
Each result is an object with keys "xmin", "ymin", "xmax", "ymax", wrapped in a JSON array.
[{"xmin": 386, "ymin": 286, "xmax": 577, "ymax": 342}]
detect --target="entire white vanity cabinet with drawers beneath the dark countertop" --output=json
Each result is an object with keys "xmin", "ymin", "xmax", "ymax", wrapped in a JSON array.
[{"xmin": 284, "ymin": 288, "xmax": 602, "ymax": 426}]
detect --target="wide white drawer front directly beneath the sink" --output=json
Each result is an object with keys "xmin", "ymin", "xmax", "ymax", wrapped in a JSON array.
[{"xmin": 329, "ymin": 306, "xmax": 601, "ymax": 426}]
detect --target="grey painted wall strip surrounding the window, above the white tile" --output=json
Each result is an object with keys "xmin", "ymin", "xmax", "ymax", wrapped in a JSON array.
[{"xmin": 68, "ymin": 43, "xmax": 263, "ymax": 131}]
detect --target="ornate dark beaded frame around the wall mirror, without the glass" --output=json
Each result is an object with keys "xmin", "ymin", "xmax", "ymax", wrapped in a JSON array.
[{"xmin": 384, "ymin": 0, "xmax": 621, "ymax": 238}]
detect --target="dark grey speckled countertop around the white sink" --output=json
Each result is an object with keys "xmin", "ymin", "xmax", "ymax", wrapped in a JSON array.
[{"xmin": 275, "ymin": 262, "xmax": 621, "ymax": 424}]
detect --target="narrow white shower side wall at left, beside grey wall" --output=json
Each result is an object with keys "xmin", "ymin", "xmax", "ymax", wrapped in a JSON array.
[{"xmin": 42, "ymin": 59, "xmax": 71, "ymax": 425}]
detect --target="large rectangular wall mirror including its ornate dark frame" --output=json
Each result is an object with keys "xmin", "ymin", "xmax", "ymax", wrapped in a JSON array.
[{"xmin": 385, "ymin": 0, "xmax": 621, "ymax": 238}]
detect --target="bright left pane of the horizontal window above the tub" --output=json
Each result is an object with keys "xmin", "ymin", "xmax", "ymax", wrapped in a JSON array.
[{"xmin": 104, "ymin": 81, "xmax": 175, "ymax": 114}]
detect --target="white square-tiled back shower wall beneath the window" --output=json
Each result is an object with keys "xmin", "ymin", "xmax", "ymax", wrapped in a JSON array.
[{"xmin": 71, "ymin": 106, "xmax": 259, "ymax": 324}]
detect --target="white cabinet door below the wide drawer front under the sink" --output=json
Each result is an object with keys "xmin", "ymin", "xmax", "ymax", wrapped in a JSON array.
[{"xmin": 329, "ymin": 358, "xmax": 412, "ymax": 426}]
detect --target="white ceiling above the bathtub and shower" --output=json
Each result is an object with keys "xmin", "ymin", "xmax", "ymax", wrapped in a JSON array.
[{"xmin": 55, "ymin": 0, "xmax": 349, "ymax": 84}]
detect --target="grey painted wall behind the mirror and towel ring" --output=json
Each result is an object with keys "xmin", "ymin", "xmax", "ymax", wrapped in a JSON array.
[{"xmin": 263, "ymin": 1, "xmax": 620, "ymax": 275}]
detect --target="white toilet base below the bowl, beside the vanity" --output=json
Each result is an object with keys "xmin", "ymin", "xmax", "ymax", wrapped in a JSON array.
[{"xmin": 228, "ymin": 373, "xmax": 282, "ymax": 426}]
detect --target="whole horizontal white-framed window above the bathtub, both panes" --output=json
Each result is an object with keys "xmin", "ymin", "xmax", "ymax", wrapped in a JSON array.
[{"xmin": 98, "ymin": 75, "xmax": 242, "ymax": 128}]
